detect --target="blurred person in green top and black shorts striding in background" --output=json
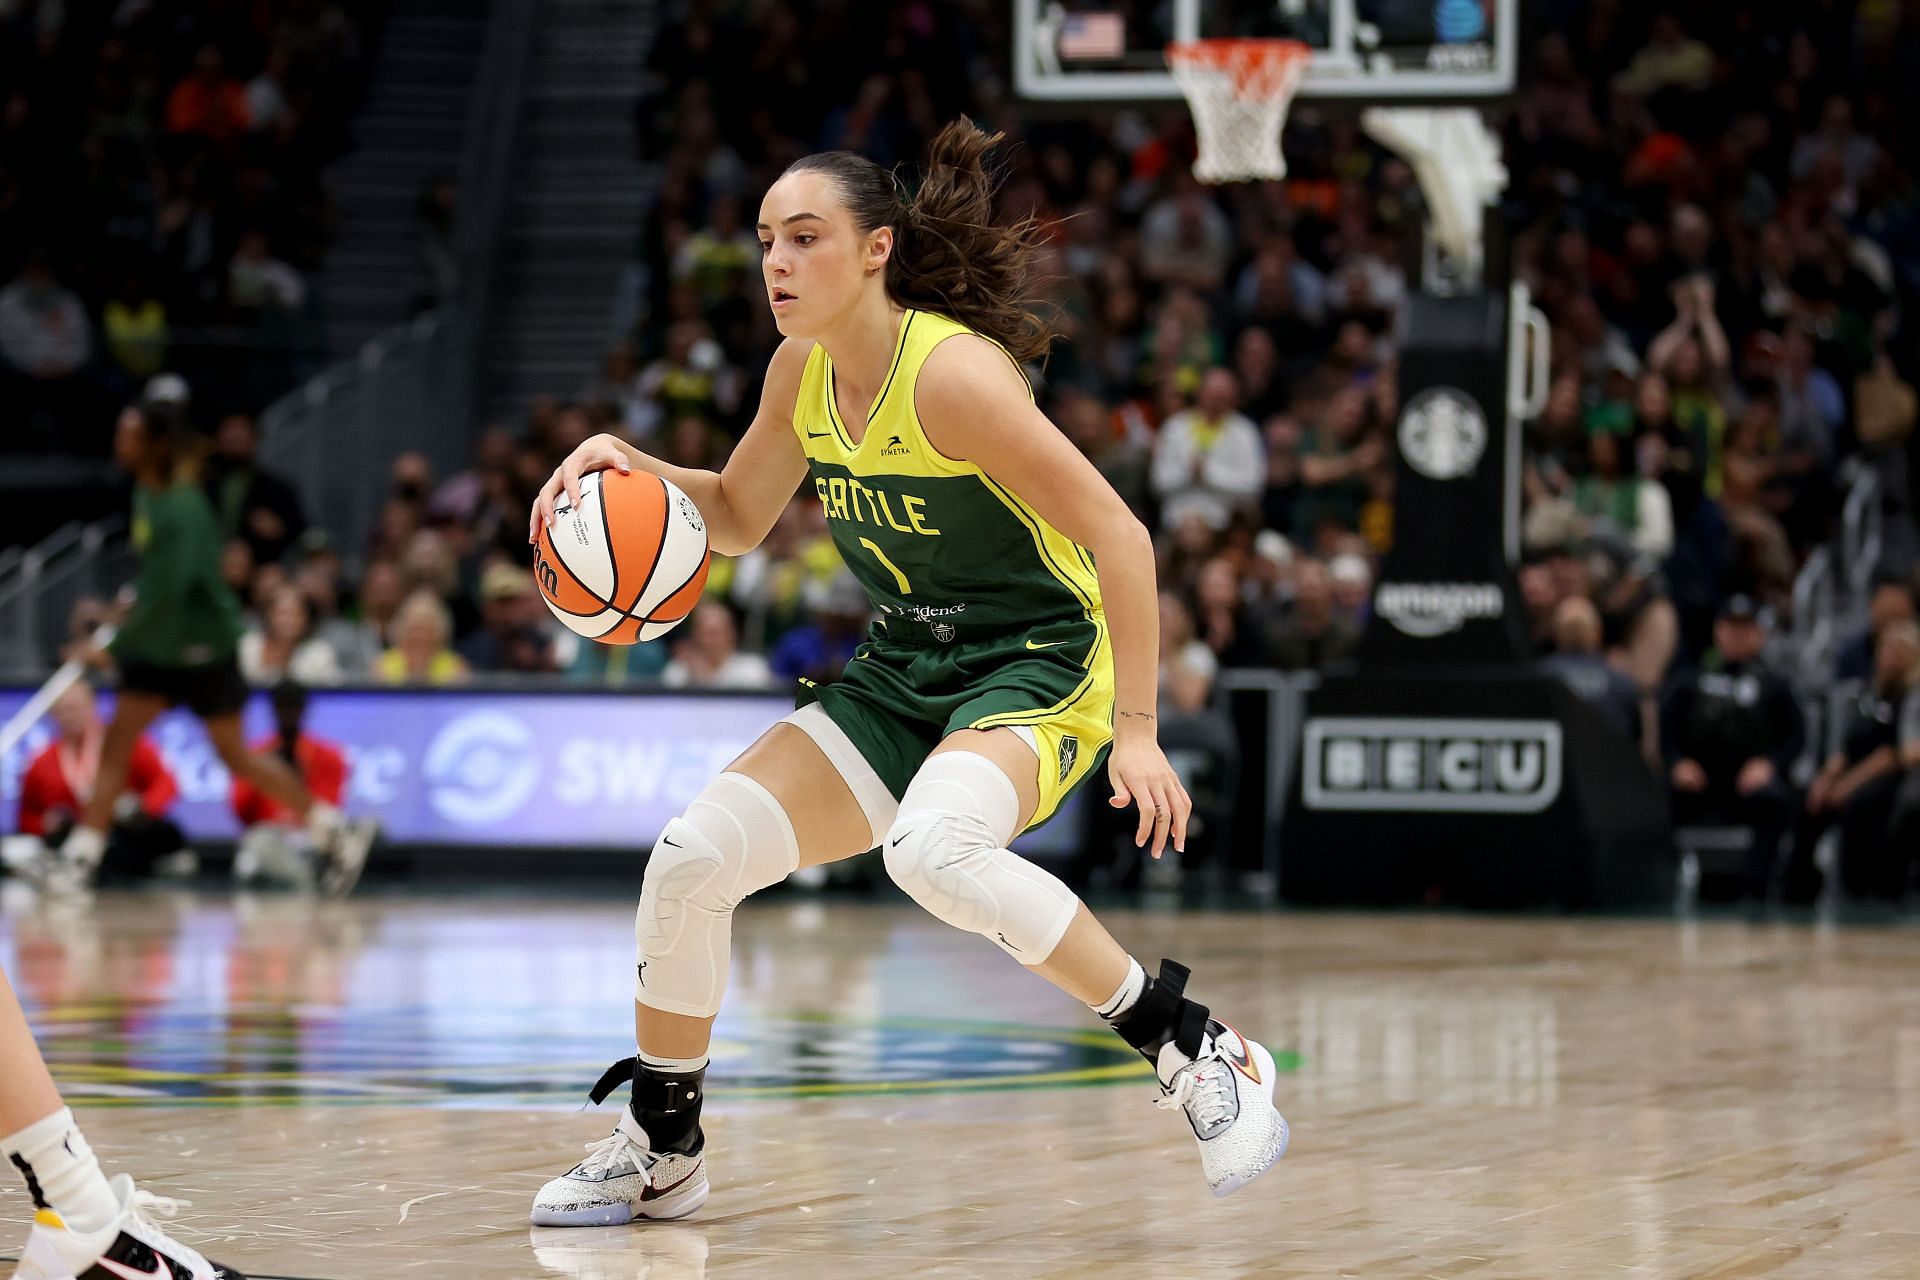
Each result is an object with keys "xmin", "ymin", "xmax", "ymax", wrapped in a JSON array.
[{"xmin": 31, "ymin": 403, "xmax": 372, "ymax": 892}]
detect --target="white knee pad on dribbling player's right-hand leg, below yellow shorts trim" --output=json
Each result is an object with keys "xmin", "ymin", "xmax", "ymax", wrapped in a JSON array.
[{"xmin": 885, "ymin": 750, "xmax": 1079, "ymax": 965}]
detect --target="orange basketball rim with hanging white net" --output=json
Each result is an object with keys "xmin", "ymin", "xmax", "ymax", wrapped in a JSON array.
[{"xmin": 1167, "ymin": 40, "xmax": 1313, "ymax": 182}]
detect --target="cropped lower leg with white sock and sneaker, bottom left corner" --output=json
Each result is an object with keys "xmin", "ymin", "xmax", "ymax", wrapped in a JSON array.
[{"xmin": 0, "ymin": 973, "xmax": 246, "ymax": 1280}]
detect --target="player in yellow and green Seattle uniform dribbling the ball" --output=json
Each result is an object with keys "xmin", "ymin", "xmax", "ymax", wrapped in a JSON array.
[{"xmin": 530, "ymin": 119, "xmax": 1286, "ymax": 1226}]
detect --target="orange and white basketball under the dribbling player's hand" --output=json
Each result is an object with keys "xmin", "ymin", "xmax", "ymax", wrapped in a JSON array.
[{"xmin": 534, "ymin": 470, "xmax": 710, "ymax": 645}]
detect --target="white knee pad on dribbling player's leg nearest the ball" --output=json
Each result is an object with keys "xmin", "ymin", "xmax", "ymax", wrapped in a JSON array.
[{"xmin": 634, "ymin": 773, "xmax": 801, "ymax": 1017}]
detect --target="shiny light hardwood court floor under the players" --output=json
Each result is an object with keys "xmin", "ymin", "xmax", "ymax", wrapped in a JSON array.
[{"xmin": 0, "ymin": 892, "xmax": 1920, "ymax": 1280}]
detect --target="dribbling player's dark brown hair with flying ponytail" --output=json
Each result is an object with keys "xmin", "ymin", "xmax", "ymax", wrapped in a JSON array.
[{"xmin": 787, "ymin": 115, "xmax": 1054, "ymax": 361}]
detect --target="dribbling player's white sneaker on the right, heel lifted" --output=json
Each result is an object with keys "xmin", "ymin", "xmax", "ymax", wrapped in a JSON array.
[{"xmin": 1154, "ymin": 1019, "xmax": 1286, "ymax": 1196}]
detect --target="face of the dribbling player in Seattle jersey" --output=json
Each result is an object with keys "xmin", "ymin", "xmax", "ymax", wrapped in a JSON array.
[{"xmin": 758, "ymin": 173, "xmax": 891, "ymax": 338}]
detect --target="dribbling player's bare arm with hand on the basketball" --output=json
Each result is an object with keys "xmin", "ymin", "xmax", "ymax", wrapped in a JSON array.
[{"xmin": 526, "ymin": 338, "xmax": 812, "ymax": 555}]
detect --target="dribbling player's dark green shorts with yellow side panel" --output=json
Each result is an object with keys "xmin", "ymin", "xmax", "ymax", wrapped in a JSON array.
[{"xmin": 797, "ymin": 614, "xmax": 1114, "ymax": 831}]
